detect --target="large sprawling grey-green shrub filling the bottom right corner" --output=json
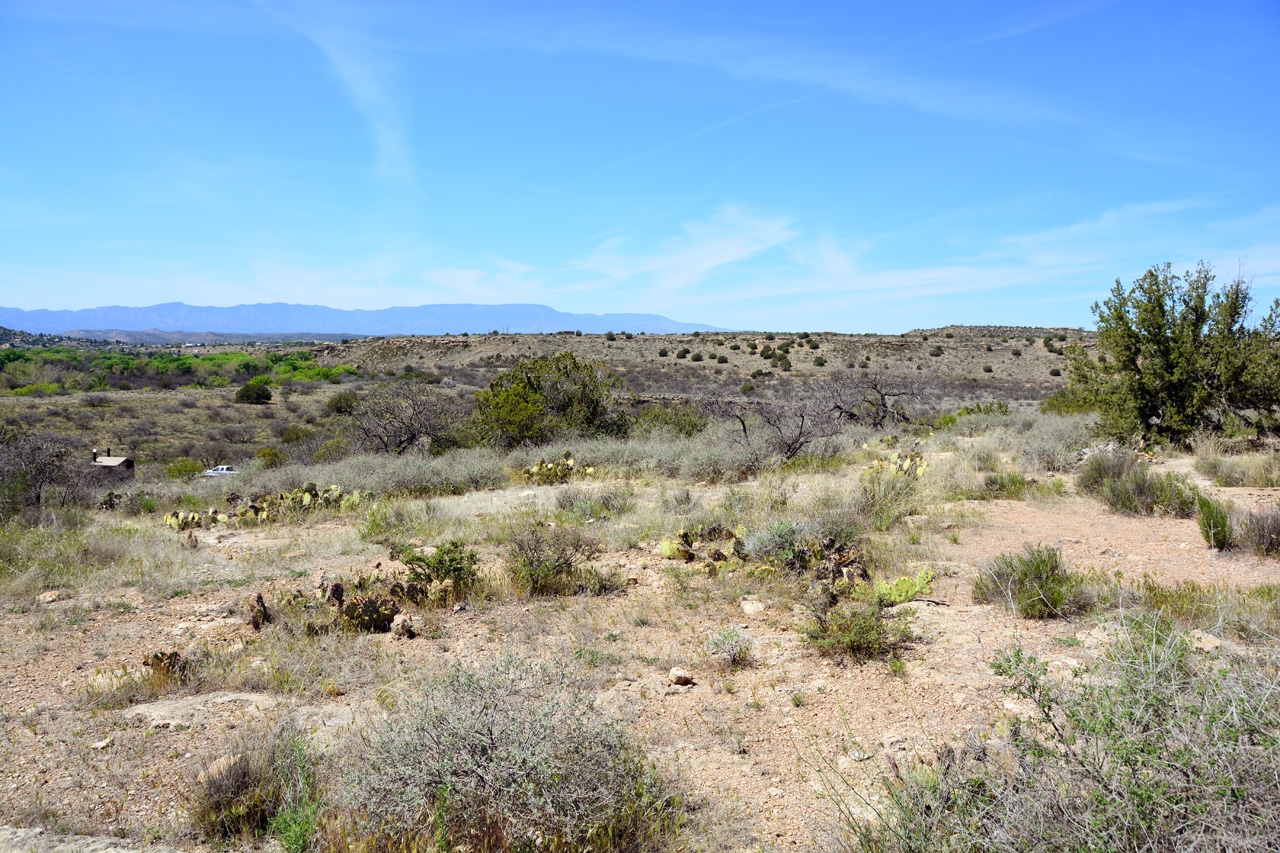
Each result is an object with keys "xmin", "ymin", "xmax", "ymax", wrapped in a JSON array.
[{"xmin": 819, "ymin": 615, "xmax": 1280, "ymax": 853}]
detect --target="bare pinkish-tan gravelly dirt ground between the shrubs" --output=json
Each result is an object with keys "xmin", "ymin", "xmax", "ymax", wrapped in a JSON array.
[{"xmin": 0, "ymin": 462, "xmax": 1280, "ymax": 850}]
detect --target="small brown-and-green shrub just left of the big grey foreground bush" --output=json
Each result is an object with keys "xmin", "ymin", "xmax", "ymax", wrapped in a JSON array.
[{"xmin": 186, "ymin": 721, "xmax": 320, "ymax": 853}]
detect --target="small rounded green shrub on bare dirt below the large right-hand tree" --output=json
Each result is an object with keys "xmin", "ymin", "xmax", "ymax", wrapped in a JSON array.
[{"xmin": 973, "ymin": 543, "xmax": 1093, "ymax": 619}]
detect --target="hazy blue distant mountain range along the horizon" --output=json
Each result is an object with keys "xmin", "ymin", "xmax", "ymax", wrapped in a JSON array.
[{"xmin": 0, "ymin": 302, "xmax": 723, "ymax": 341}]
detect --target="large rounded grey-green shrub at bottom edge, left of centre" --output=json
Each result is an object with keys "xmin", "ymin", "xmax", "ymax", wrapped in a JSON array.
[{"xmin": 346, "ymin": 657, "xmax": 680, "ymax": 853}]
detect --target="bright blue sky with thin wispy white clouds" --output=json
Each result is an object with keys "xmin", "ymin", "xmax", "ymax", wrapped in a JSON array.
[{"xmin": 0, "ymin": 0, "xmax": 1280, "ymax": 332}]
